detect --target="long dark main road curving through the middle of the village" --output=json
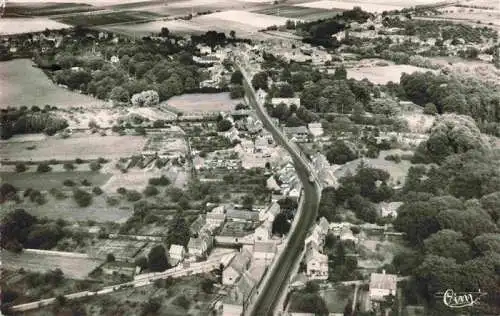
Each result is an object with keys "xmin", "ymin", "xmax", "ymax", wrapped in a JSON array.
[{"xmin": 237, "ymin": 60, "xmax": 321, "ymax": 316}]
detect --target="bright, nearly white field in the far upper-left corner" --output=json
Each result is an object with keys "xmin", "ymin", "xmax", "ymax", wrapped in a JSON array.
[{"xmin": 0, "ymin": 18, "xmax": 70, "ymax": 35}]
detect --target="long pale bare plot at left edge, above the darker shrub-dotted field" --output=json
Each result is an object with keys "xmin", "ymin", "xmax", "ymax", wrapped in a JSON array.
[{"xmin": 0, "ymin": 134, "xmax": 146, "ymax": 161}]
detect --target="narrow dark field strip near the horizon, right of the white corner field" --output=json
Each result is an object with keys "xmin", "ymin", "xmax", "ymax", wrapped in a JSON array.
[{"xmin": 57, "ymin": 11, "xmax": 162, "ymax": 26}]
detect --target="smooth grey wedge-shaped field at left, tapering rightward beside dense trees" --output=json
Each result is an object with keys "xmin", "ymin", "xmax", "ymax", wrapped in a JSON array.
[{"xmin": 0, "ymin": 59, "xmax": 105, "ymax": 109}]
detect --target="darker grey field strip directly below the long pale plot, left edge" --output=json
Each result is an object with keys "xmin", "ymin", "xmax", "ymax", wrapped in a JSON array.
[{"xmin": 0, "ymin": 171, "xmax": 111, "ymax": 191}]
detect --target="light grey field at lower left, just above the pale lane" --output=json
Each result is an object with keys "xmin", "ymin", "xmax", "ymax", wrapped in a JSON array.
[{"xmin": 2, "ymin": 251, "xmax": 102, "ymax": 279}]
